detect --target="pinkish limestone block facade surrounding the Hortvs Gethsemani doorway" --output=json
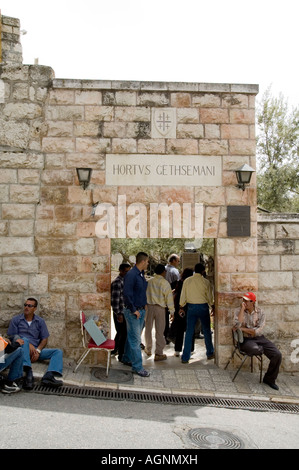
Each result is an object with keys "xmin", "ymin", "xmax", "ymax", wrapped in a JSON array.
[{"xmin": 39, "ymin": 80, "xmax": 257, "ymax": 364}]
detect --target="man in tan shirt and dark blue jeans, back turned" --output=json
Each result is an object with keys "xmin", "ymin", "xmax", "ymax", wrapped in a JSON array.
[{"xmin": 180, "ymin": 263, "xmax": 215, "ymax": 364}]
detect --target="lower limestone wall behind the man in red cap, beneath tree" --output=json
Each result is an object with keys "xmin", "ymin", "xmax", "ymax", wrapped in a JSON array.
[{"xmin": 258, "ymin": 214, "xmax": 299, "ymax": 372}]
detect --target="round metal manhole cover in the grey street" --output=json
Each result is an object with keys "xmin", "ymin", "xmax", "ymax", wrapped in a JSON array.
[{"xmin": 188, "ymin": 428, "xmax": 244, "ymax": 449}]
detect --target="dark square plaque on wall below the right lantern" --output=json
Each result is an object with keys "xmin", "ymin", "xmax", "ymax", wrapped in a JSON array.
[{"xmin": 227, "ymin": 206, "xmax": 250, "ymax": 237}]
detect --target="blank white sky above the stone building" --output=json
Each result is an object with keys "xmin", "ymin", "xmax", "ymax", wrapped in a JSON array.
[{"xmin": 0, "ymin": 0, "xmax": 299, "ymax": 106}]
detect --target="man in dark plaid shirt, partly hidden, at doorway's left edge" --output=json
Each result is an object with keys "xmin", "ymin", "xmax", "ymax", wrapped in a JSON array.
[{"xmin": 111, "ymin": 263, "xmax": 131, "ymax": 361}]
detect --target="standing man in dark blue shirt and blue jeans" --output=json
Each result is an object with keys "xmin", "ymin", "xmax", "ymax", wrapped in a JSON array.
[{"xmin": 122, "ymin": 252, "xmax": 150, "ymax": 377}]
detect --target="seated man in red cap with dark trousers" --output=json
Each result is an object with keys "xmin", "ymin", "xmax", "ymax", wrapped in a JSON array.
[{"xmin": 233, "ymin": 292, "xmax": 282, "ymax": 390}]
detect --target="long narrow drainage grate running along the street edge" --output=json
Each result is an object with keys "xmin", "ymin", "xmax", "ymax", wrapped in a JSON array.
[{"xmin": 33, "ymin": 384, "xmax": 299, "ymax": 414}]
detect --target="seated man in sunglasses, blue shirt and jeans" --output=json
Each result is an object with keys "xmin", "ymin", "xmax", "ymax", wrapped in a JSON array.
[{"xmin": 7, "ymin": 297, "xmax": 63, "ymax": 390}]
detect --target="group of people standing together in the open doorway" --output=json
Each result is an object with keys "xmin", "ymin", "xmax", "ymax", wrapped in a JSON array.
[{"xmin": 111, "ymin": 252, "xmax": 214, "ymax": 377}]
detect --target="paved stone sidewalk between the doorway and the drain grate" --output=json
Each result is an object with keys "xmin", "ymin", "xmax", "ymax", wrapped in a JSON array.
[{"xmin": 33, "ymin": 340, "xmax": 299, "ymax": 404}]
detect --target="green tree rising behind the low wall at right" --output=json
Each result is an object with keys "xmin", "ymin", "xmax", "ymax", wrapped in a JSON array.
[{"xmin": 257, "ymin": 88, "xmax": 299, "ymax": 212}]
